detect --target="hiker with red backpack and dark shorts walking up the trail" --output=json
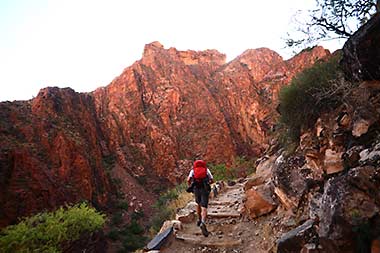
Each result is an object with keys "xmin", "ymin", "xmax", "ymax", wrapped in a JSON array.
[{"xmin": 187, "ymin": 160, "xmax": 214, "ymax": 237}]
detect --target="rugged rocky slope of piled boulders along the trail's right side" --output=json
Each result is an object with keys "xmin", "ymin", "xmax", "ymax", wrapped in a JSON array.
[{"xmin": 271, "ymin": 14, "xmax": 380, "ymax": 253}]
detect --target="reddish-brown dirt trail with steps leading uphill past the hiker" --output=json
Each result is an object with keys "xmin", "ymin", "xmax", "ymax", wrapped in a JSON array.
[{"xmin": 160, "ymin": 182, "xmax": 289, "ymax": 253}]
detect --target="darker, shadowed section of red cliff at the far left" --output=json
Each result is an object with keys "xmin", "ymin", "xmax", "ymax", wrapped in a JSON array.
[{"xmin": 0, "ymin": 88, "xmax": 112, "ymax": 226}]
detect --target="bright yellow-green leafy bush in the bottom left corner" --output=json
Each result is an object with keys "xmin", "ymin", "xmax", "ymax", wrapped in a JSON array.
[{"xmin": 0, "ymin": 203, "xmax": 105, "ymax": 252}]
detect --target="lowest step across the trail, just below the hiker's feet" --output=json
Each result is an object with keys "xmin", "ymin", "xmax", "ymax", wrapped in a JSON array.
[{"xmin": 176, "ymin": 234, "xmax": 242, "ymax": 248}]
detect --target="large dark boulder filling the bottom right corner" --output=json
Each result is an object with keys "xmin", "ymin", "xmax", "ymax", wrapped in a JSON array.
[{"xmin": 318, "ymin": 167, "xmax": 380, "ymax": 253}]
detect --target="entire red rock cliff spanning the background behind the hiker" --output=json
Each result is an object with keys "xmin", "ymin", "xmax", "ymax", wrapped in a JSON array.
[{"xmin": 0, "ymin": 42, "xmax": 329, "ymax": 226}]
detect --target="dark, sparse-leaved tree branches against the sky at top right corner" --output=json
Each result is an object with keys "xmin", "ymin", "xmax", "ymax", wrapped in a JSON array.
[{"xmin": 286, "ymin": 0, "xmax": 379, "ymax": 47}]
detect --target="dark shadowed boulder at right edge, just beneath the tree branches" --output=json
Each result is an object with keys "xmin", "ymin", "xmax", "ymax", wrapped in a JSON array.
[{"xmin": 341, "ymin": 14, "xmax": 380, "ymax": 81}]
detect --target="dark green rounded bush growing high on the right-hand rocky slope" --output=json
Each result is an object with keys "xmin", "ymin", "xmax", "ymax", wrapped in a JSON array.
[{"xmin": 278, "ymin": 54, "xmax": 347, "ymax": 140}]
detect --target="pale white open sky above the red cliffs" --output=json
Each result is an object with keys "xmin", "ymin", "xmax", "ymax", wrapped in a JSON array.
[{"xmin": 0, "ymin": 0, "xmax": 342, "ymax": 101}]
